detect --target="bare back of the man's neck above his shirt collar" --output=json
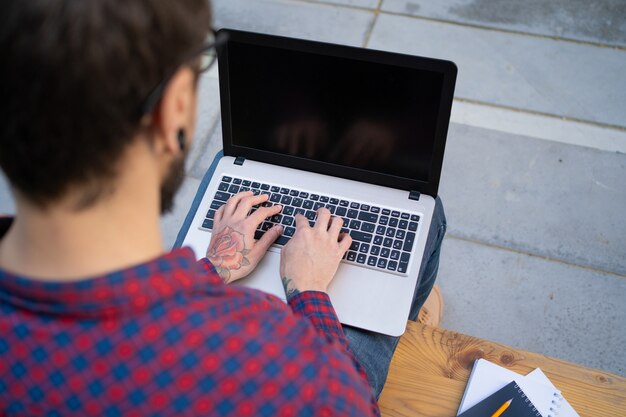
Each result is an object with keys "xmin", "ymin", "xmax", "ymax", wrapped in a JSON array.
[{"xmin": 0, "ymin": 151, "xmax": 163, "ymax": 281}]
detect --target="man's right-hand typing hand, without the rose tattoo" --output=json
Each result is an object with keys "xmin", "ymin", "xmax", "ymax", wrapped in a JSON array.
[{"xmin": 280, "ymin": 208, "xmax": 352, "ymax": 298}]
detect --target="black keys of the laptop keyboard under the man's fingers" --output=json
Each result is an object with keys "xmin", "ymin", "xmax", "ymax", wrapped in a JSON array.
[{"xmin": 202, "ymin": 176, "xmax": 420, "ymax": 275}]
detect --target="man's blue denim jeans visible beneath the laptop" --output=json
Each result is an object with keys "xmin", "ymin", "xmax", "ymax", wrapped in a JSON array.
[{"xmin": 343, "ymin": 197, "xmax": 447, "ymax": 399}]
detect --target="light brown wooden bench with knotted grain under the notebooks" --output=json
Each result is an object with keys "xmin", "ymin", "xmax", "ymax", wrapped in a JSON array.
[{"xmin": 379, "ymin": 322, "xmax": 626, "ymax": 417}]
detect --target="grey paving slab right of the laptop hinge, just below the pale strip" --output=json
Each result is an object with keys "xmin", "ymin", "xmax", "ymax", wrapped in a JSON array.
[{"xmin": 440, "ymin": 123, "xmax": 626, "ymax": 276}]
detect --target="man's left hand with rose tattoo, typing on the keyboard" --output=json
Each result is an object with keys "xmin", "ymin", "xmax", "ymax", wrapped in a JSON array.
[{"xmin": 206, "ymin": 191, "xmax": 283, "ymax": 284}]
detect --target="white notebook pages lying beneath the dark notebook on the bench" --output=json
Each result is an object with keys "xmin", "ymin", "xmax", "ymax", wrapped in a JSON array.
[{"xmin": 458, "ymin": 359, "xmax": 579, "ymax": 417}]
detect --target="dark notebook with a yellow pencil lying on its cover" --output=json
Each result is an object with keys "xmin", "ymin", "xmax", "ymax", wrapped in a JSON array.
[{"xmin": 459, "ymin": 381, "xmax": 541, "ymax": 417}]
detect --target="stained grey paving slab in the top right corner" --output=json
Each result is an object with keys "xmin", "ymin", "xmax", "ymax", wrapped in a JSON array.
[{"xmin": 382, "ymin": 0, "xmax": 626, "ymax": 47}]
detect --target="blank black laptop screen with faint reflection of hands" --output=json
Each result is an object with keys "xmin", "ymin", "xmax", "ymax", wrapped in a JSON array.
[{"xmin": 228, "ymin": 41, "xmax": 443, "ymax": 181}]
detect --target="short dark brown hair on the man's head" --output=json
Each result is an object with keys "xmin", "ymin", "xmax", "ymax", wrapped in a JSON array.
[{"xmin": 0, "ymin": 0, "xmax": 210, "ymax": 207}]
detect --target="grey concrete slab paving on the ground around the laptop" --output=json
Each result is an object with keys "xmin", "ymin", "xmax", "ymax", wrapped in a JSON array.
[{"xmin": 0, "ymin": 0, "xmax": 626, "ymax": 375}]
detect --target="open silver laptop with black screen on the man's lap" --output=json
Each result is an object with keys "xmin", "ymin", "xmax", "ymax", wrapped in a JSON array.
[{"xmin": 183, "ymin": 29, "xmax": 457, "ymax": 336}]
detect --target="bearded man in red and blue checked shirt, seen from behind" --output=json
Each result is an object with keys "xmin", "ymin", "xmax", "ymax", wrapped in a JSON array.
[{"xmin": 0, "ymin": 0, "xmax": 445, "ymax": 416}]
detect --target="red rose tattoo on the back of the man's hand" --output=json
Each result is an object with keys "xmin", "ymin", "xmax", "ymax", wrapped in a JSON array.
[{"xmin": 207, "ymin": 227, "xmax": 250, "ymax": 283}]
